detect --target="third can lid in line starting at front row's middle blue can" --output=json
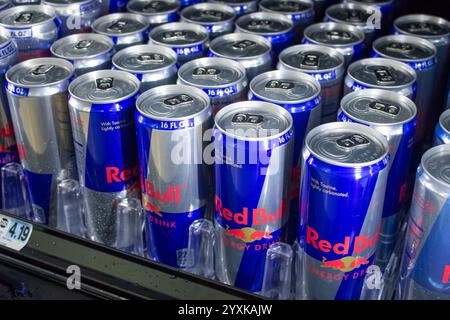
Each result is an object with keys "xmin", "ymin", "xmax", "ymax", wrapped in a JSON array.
[{"xmin": 279, "ymin": 44, "xmax": 344, "ymax": 73}]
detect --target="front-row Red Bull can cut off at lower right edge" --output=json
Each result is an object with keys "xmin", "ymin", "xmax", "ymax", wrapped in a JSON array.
[{"xmin": 398, "ymin": 144, "xmax": 450, "ymax": 300}]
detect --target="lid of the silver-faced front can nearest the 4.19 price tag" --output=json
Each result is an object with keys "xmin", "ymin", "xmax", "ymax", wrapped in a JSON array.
[{"xmin": 6, "ymin": 58, "xmax": 73, "ymax": 88}]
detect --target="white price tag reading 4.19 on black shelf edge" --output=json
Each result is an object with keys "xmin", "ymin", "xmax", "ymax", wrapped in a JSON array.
[{"xmin": 0, "ymin": 214, "xmax": 33, "ymax": 251}]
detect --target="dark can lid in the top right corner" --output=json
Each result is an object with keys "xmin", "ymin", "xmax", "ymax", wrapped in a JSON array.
[{"xmin": 394, "ymin": 14, "xmax": 450, "ymax": 38}]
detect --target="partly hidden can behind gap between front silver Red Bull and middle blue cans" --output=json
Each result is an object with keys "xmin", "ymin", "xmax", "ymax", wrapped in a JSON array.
[{"xmin": 178, "ymin": 58, "xmax": 248, "ymax": 114}]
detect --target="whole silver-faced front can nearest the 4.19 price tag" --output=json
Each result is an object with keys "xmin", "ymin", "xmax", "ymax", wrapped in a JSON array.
[{"xmin": 6, "ymin": 58, "xmax": 77, "ymax": 227}]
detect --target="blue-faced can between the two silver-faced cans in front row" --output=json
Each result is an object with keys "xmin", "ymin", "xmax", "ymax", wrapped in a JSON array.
[{"xmin": 69, "ymin": 70, "xmax": 140, "ymax": 246}]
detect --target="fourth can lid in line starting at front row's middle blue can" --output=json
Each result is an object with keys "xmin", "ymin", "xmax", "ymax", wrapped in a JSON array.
[{"xmin": 304, "ymin": 22, "xmax": 365, "ymax": 47}]
